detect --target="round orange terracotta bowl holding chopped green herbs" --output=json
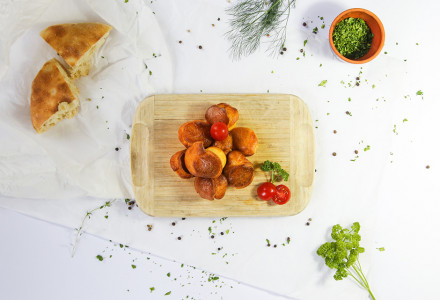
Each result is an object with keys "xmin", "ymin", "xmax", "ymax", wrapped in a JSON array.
[{"xmin": 329, "ymin": 8, "xmax": 385, "ymax": 64}]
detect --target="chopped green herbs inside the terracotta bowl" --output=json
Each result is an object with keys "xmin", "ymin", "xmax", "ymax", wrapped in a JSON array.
[{"xmin": 333, "ymin": 18, "xmax": 374, "ymax": 59}]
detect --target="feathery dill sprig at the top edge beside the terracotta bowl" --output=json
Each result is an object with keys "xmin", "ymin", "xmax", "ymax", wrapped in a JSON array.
[{"xmin": 226, "ymin": 0, "xmax": 295, "ymax": 59}]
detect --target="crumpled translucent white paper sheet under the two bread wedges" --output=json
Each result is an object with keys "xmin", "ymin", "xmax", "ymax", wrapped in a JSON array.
[{"xmin": 0, "ymin": 0, "xmax": 172, "ymax": 199}]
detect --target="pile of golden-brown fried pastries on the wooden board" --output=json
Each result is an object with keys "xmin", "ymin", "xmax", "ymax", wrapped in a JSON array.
[{"xmin": 170, "ymin": 103, "xmax": 258, "ymax": 200}]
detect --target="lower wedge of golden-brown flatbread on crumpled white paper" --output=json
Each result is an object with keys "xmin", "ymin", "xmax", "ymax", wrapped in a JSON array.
[{"xmin": 31, "ymin": 58, "xmax": 79, "ymax": 133}]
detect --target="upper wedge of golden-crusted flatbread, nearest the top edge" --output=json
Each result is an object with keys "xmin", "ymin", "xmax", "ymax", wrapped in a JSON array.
[{"xmin": 40, "ymin": 23, "xmax": 112, "ymax": 79}]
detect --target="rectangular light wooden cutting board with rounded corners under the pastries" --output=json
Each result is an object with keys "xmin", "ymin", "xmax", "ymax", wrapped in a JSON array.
[{"xmin": 131, "ymin": 94, "xmax": 315, "ymax": 217}]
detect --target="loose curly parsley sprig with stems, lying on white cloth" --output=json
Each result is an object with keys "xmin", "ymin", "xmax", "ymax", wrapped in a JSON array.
[{"xmin": 316, "ymin": 222, "xmax": 376, "ymax": 300}]
